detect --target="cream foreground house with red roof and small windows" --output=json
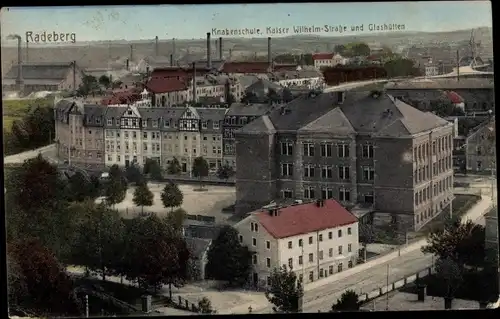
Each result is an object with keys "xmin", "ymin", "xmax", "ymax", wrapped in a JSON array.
[{"xmin": 235, "ymin": 199, "xmax": 359, "ymax": 287}]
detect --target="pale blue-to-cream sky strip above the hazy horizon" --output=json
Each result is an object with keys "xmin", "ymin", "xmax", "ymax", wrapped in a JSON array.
[{"xmin": 0, "ymin": 1, "xmax": 492, "ymax": 42}]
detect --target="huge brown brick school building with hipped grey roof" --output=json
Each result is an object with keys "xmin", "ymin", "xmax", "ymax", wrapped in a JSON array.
[{"xmin": 235, "ymin": 91, "xmax": 453, "ymax": 230}]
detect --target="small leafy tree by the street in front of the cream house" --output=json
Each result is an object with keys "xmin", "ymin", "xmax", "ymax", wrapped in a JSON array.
[{"xmin": 266, "ymin": 267, "xmax": 304, "ymax": 313}]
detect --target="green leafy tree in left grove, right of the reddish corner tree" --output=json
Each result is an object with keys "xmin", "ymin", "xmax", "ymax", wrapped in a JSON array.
[{"xmin": 72, "ymin": 201, "xmax": 124, "ymax": 280}]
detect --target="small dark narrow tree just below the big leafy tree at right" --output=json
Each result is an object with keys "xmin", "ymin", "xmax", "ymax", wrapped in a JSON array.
[{"xmin": 436, "ymin": 257, "xmax": 464, "ymax": 309}]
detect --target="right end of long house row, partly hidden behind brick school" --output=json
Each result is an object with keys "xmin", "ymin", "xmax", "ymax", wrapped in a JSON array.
[{"xmin": 222, "ymin": 103, "xmax": 274, "ymax": 169}]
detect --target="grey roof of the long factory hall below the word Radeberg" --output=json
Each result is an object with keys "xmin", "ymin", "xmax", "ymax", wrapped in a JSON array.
[{"xmin": 5, "ymin": 62, "xmax": 72, "ymax": 81}]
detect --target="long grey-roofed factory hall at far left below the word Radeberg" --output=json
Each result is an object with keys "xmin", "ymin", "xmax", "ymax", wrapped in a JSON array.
[{"xmin": 2, "ymin": 62, "xmax": 83, "ymax": 93}]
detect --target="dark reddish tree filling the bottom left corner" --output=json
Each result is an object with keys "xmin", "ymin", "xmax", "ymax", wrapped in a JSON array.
[{"xmin": 8, "ymin": 239, "xmax": 81, "ymax": 316}]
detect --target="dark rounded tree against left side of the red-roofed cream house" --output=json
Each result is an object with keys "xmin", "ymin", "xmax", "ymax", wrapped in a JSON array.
[{"xmin": 206, "ymin": 226, "xmax": 252, "ymax": 285}]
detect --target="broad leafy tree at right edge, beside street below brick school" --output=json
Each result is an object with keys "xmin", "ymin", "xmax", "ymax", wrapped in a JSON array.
[{"xmin": 422, "ymin": 220, "xmax": 485, "ymax": 266}]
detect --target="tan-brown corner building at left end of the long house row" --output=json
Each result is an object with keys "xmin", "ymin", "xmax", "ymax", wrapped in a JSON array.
[{"xmin": 54, "ymin": 100, "xmax": 104, "ymax": 169}]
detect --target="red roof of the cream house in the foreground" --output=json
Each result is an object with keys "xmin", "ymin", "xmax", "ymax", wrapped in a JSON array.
[{"xmin": 255, "ymin": 199, "xmax": 358, "ymax": 238}]
